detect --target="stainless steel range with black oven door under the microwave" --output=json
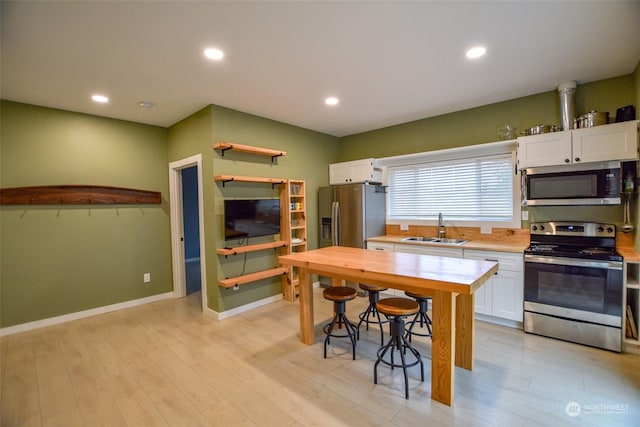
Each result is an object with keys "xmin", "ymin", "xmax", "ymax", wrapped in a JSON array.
[{"xmin": 524, "ymin": 222, "xmax": 623, "ymax": 352}]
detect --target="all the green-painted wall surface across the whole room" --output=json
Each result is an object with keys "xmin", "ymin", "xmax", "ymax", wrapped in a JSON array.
[{"xmin": 0, "ymin": 70, "xmax": 640, "ymax": 327}]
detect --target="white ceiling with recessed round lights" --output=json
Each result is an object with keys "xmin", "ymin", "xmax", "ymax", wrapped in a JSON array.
[{"xmin": 0, "ymin": 0, "xmax": 640, "ymax": 136}]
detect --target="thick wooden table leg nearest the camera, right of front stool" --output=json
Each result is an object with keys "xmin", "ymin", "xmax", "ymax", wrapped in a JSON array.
[{"xmin": 431, "ymin": 291, "xmax": 456, "ymax": 406}]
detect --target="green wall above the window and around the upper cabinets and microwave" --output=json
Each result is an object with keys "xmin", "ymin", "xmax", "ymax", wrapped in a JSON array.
[{"xmin": 338, "ymin": 76, "xmax": 640, "ymax": 228}]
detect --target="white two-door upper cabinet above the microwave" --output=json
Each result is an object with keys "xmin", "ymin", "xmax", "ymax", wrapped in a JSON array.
[{"xmin": 518, "ymin": 120, "xmax": 638, "ymax": 169}]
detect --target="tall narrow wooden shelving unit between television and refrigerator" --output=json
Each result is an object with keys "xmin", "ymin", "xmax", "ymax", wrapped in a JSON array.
[{"xmin": 281, "ymin": 179, "xmax": 307, "ymax": 301}]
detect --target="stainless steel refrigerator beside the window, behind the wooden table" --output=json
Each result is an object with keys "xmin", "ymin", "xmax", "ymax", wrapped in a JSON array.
[{"xmin": 318, "ymin": 184, "xmax": 386, "ymax": 286}]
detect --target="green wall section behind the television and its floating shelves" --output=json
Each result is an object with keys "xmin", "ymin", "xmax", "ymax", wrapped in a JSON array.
[{"xmin": 169, "ymin": 105, "xmax": 338, "ymax": 312}]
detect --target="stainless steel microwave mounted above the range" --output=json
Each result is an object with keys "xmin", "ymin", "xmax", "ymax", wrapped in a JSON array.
[{"xmin": 524, "ymin": 162, "xmax": 622, "ymax": 206}]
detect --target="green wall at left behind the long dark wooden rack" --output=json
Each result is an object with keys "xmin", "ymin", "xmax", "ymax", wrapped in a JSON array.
[{"xmin": 0, "ymin": 101, "xmax": 172, "ymax": 327}]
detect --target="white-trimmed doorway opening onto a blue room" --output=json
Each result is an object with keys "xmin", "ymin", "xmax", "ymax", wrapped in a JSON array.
[{"xmin": 169, "ymin": 154, "xmax": 207, "ymax": 311}]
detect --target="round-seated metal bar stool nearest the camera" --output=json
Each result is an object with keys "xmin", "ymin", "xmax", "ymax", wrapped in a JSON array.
[{"xmin": 373, "ymin": 298, "xmax": 424, "ymax": 399}]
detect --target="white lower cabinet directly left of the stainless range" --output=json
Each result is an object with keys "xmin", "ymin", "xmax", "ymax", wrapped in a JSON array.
[{"xmin": 464, "ymin": 250, "xmax": 524, "ymax": 323}]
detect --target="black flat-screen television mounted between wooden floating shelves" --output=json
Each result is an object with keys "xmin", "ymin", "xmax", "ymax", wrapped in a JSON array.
[{"xmin": 224, "ymin": 199, "xmax": 280, "ymax": 240}]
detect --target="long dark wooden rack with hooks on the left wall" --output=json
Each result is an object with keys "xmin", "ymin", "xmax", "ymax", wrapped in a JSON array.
[{"xmin": 0, "ymin": 185, "xmax": 160, "ymax": 205}]
